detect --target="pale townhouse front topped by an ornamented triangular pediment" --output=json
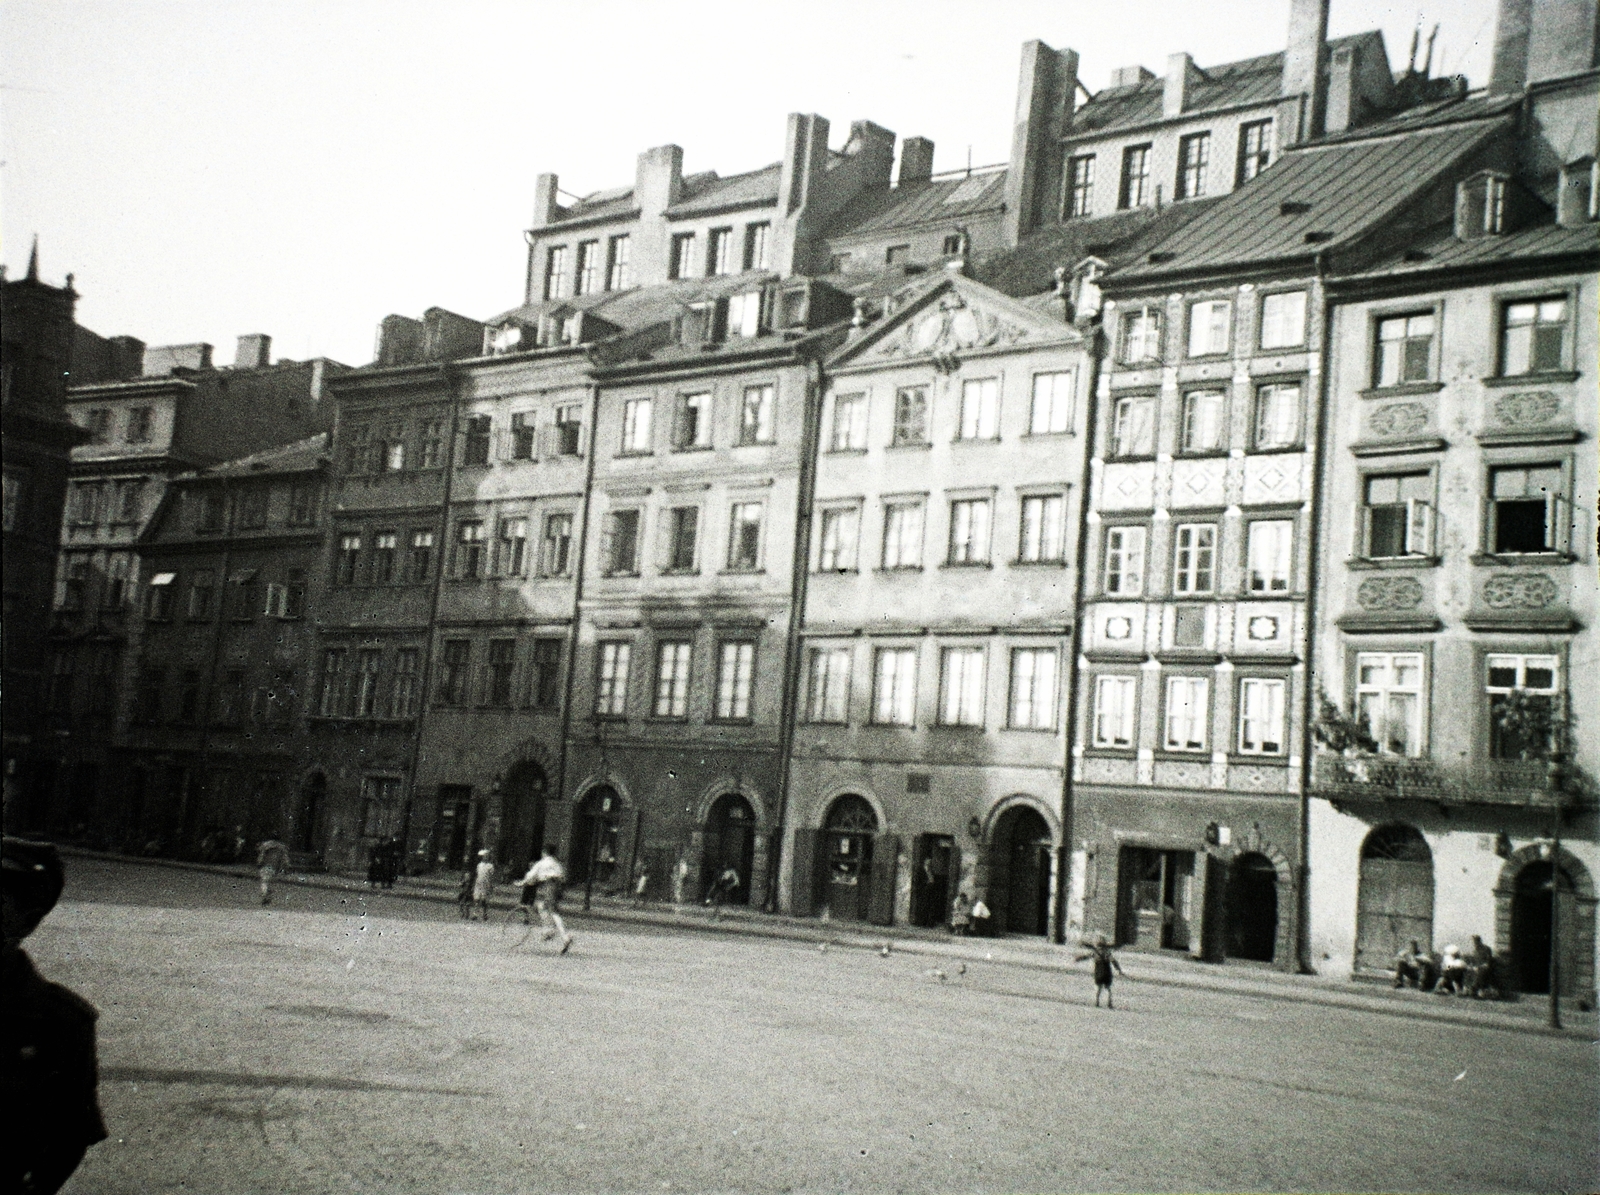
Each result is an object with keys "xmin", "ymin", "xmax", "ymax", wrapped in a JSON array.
[{"xmin": 782, "ymin": 272, "xmax": 1090, "ymax": 934}]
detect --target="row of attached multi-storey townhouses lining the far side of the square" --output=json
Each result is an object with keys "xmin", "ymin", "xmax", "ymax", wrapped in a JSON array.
[{"xmin": 21, "ymin": 0, "xmax": 1600, "ymax": 998}]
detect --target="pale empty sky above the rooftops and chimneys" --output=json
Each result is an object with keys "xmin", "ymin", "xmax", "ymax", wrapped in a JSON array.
[{"xmin": 0, "ymin": 0, "xmax": 1496, "ymax": 365}]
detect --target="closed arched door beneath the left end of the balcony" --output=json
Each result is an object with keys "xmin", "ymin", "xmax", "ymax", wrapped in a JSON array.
[{"xmin": 1355, "ymin": 822, "xmax": 1434, "ymax": 971}]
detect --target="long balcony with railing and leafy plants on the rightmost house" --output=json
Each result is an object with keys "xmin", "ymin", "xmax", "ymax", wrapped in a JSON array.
[{"xmin": 1310, "ymin": 752, "xmax": 1594, "ymax": 809}]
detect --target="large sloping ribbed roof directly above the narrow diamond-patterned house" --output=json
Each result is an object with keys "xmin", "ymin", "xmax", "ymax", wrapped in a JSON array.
[{"xmin": 1110, "ymin": 120, "xmax": 1504, "ymax": 282}]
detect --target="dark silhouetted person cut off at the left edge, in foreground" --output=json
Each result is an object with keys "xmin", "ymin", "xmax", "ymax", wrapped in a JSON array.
[{"xmin": 0, "ymin": 838, "xmax": 106, "ymax": 1192}]
